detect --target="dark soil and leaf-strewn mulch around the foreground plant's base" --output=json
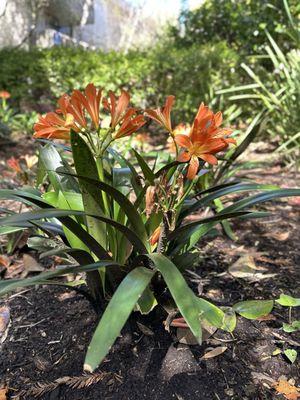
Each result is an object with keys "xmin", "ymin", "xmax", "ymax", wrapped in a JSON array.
[{"xmin": 0, "ymin": 137, "xmax": 300, "ymax": 400}]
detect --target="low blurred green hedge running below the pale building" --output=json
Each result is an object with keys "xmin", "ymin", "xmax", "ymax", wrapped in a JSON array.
[{"xmin": 0, "ymin": 42, "xmax": 238, "ymax": 122}]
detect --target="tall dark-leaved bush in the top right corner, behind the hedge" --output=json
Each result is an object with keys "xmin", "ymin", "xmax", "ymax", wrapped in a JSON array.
[{"xmin": 170, "ymin": 0, "xmax": 299, "ymax": 55}]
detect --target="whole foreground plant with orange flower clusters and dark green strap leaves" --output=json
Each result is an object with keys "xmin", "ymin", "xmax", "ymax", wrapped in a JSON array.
[{"xmin": 0, "ymin": 84, "xmax": 300, "ymax": 372}]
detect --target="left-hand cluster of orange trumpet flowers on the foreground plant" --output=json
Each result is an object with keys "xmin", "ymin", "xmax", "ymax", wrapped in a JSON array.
[{"xmin": 33, "ymin": 83, "xmax": 145, "ymax": 140}]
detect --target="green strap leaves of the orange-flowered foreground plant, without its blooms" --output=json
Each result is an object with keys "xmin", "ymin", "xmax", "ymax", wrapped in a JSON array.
[{"xmin": 0, "ymin": 119, "xmax": 300, "ymax": 371}]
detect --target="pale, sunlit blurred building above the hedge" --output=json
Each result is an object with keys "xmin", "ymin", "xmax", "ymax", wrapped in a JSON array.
[{"xmin": 0, "ymin": 0, "xmax": 203, "ymax": 51}]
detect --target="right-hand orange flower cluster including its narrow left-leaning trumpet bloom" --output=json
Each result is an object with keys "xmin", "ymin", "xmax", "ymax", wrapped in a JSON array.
[{"xmin": 147, "ymin": 96, "xmax": 236, "ymax": 179}]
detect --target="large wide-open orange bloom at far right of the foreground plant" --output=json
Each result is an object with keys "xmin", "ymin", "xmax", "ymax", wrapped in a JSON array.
[{"xmin": 175, "ymin": 103, "xmax": 236, "ymax": 179}]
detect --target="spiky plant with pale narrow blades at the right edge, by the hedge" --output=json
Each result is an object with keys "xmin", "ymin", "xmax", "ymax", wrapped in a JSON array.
[{"xmin": 219, "ymin": 33, "xmax": 300, "ymax": 158}]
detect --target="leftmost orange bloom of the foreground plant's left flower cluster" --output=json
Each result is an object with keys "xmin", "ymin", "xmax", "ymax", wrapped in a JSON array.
[{"xmin": 33, "ymin": 112, "xmax": 74, "ymax": 140}]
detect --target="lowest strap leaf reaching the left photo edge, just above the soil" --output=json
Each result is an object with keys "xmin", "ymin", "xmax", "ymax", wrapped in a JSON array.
[{"xmin": 0, "ymin": 260, "xmax": 119, "ymax": 296}]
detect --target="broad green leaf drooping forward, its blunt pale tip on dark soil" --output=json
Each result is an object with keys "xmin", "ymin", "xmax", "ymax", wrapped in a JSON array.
[{"xmin": 84, "ymin": 267, "xmax": 154, "ymax": 372}]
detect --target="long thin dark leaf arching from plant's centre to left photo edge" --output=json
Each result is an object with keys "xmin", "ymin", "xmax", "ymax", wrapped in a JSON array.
[{"xmin": 0, "ymin": 208, "xmax": 147, "ymax": 254}]
